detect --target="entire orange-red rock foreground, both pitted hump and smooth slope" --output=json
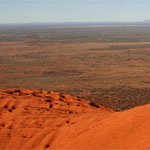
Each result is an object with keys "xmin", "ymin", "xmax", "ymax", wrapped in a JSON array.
[{"xmin": 0, "ymin": 89, "xmax": 150, "ymax": 150}]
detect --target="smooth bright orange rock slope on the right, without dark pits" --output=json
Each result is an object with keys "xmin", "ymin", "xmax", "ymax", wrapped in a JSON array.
[{"xmin": 52, "ymin": 105, "xmax": 150, "ymax": 150}]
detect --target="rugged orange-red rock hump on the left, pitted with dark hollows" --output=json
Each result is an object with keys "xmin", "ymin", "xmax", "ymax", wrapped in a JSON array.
[{"xmin": 0, "ymin": 89, "xmax": 113, "ymax": 150}]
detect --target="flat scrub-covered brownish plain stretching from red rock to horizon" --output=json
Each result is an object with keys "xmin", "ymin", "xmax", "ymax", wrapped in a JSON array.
[{"xmin": 0, "ymin": 24, "xmax": 150, "ymax": 111}]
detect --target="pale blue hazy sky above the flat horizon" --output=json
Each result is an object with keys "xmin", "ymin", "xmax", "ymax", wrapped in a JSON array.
[{"xmin": 0, "ymin": 0, "xmax": 150, "ymax": 23}]
